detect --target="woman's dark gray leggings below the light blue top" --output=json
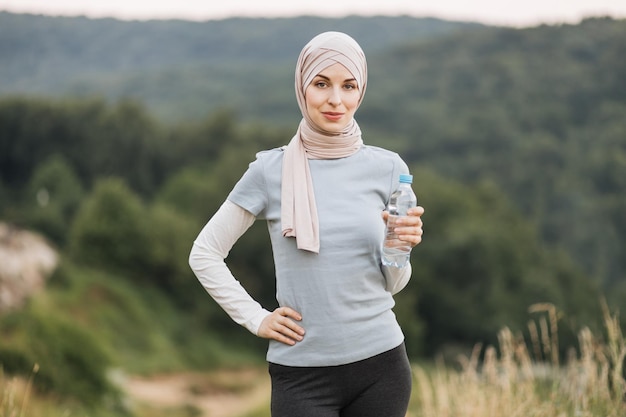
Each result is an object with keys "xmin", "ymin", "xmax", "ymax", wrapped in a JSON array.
[{"xmin": 269, "ymin": 343, "xmax": 412, "ymax": 417}]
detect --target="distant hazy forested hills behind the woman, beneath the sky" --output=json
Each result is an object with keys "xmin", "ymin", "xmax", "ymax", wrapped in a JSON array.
[{"xmin": 0, "ymin": 13, "xmax": 626, "ymax": 285}]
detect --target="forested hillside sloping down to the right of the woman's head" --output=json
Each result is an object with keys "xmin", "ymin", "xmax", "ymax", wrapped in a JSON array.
[{"xmin": 364, "ymin": 19, "xmax": 626, "ymax": 290}]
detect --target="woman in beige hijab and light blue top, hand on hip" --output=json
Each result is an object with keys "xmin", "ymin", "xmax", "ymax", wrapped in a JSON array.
[{"xmin": 189, "ymin": 32, "xmax": 424, "ymax": 417}]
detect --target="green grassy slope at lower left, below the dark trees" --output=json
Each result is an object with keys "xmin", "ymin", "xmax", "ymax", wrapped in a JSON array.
[{"xmin": 0, "ymin": 255, "xmax": 263, "ymax": 416}]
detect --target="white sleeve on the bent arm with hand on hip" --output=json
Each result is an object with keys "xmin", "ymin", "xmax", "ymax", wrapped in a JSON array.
[{"xmin": 189, "ymin": 200, "xmax": 270, "ymax": 335}]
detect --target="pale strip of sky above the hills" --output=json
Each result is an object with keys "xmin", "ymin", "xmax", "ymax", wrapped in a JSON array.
[{"xmin": 0, "ymin": 0, "xmax": 626, "ymax": 27}]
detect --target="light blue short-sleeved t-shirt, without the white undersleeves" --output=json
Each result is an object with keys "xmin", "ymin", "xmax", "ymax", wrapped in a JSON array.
[{"xmin": 228, "ymin": 146, "xmax": 408, "ymax": 366}]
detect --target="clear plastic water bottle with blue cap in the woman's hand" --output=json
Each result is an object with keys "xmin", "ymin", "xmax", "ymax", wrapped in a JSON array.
[{"xmin": 383, "ymin": 174, "xmax": 417, "ymax": 268}]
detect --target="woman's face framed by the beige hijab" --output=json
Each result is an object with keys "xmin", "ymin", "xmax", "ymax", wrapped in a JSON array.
[{"xmin": 304, "ymin": 64, "xmax": 361, "ymax": 132}]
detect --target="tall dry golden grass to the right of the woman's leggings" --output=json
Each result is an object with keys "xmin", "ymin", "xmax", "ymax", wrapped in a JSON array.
[{"xmin": 410, "ymin": 304, "xmax": 626, "ymax": 417}]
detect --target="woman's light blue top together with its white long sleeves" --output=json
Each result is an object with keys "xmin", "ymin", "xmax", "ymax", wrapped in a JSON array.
[{"xmin": 190, "ymin": 146, "xmax": 411, "ymax": 366}]
